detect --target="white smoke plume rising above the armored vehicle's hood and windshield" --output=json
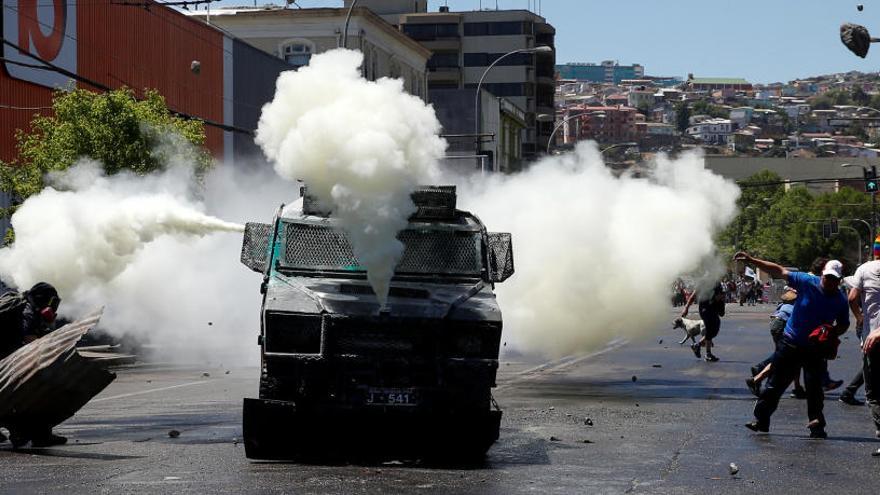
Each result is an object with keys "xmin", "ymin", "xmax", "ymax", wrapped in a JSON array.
[{"xmin": 256, "ymin": 50, "xmax": 446, "ymax": 305}]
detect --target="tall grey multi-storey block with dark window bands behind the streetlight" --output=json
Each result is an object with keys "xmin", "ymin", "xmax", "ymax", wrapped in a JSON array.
[{"xmin": 398, "ymin": 7, "xmax": 556, "ymax": 160}]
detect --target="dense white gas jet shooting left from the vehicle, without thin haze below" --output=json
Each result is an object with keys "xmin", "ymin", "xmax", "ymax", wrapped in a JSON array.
[{"xmin": 0, "ymin": 161, "xmax": 243, "ymax": 292}]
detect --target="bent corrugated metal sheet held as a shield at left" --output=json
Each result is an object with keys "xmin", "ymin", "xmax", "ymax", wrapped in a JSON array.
[{"xmin": 0, "ymin": 309, "xmax": 116, "ymax": 431}]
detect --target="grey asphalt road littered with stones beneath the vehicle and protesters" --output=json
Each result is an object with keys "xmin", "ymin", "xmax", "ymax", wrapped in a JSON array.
[{"xmin": 0, "ymin": 307, "xmax": 880, "ymax": 494}]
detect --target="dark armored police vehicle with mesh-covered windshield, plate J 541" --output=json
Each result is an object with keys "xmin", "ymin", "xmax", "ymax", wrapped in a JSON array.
[{"xmin": 241, "ymin": 186, "xmax": 513, "ymax": 459}]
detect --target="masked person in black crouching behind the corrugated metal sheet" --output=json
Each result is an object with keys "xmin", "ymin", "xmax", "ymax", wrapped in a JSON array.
[{"xmin": 0, "ymin": 282, "xmax": 67, "ymax": 447}]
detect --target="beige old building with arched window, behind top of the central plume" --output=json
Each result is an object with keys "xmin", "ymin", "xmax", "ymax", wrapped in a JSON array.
[{"xmin": 188, "ymin": 6, "xmax": 431, "ymax": 100}]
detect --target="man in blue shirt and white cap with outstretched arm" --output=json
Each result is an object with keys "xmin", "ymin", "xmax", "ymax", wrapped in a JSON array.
[{"xmin": 734, "ymin": 252, "xmax": 849, "ymax": 438}]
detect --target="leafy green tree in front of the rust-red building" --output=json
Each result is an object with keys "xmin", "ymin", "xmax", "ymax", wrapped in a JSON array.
[{"xmin": 0, "ymin": 89, "xmax": 211, "ymax": 203}]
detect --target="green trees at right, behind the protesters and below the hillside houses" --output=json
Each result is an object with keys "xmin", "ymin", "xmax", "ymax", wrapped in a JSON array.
[{"xmin": 718, "ymin": 171, "xmax": 871, "ymax": 268}]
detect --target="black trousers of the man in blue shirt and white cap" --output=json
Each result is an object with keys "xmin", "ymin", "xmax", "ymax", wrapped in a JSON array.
[{"xmin": 755, "ymin": 338, "xmax": 826, "ymax": 428}]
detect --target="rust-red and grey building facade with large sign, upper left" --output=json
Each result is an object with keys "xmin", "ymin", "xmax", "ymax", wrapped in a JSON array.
[{"xmin": 0, "ymin": 0, "xmax": 290, "ymax": 162}]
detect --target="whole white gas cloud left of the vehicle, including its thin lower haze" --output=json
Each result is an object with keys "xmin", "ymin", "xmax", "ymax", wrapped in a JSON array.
[{"xmin": 0, "ymin": 160, "xmax": 290, "ymax": 365}]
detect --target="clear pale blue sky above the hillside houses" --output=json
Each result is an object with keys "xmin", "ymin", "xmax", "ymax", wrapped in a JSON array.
[{"xmin": 215, "ymin": 0, "xmax": 880, "ymax": 83}]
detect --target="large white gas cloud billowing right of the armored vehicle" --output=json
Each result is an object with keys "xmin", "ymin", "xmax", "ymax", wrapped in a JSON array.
[{"xmin": 459, "ymin": 143, "xmax": 739, "ymax": 356}]
